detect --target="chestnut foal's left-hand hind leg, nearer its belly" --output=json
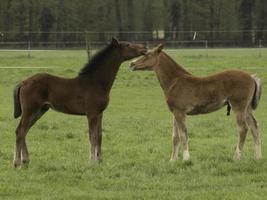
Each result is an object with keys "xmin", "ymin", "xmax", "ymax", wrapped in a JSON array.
[{"xmin": 235, "ymin": 112, "xmax": 248, "ymax": 160}]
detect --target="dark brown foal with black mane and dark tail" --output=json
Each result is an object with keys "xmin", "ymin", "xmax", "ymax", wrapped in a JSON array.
[{"xmin": 13, "ymin": 38, "xmax": 146, "ymax": 167}]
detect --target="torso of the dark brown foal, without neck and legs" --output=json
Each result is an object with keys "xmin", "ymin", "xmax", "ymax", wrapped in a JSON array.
[{"xmin": 18, "ymin": 73, "xmax": 100, "ymax": 115}]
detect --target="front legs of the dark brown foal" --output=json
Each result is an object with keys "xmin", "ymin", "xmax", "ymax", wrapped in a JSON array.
[{"xmin": 88, "ymin": 114, "xmax": 102, "ymax": 161}]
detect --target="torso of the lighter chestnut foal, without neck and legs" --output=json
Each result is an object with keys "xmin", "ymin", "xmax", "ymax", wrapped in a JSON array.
[{"xmin": 170, "ymin": 70, "xmax": 255, "ymax": 115}]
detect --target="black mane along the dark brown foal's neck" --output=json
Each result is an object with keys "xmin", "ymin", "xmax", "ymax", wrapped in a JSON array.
[{"xmin": 79, "ymin": 43, "xmax": 113, "ymax": 76}]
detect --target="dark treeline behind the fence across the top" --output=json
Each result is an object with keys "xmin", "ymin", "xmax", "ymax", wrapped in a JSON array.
[{"xmin": 0, "ymin": 0, "xmax": 267, "ymax": 45}]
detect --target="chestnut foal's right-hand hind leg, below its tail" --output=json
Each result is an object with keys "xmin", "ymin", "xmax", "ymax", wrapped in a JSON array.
[{"xmin": 247, "ymin": 111, "xmax": 262, "ymax": 159}]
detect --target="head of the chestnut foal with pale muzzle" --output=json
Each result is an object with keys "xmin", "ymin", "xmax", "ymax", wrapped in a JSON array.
[{"xmin": 130, "ymin": 44, "xmax": 163, "ymax": 71}]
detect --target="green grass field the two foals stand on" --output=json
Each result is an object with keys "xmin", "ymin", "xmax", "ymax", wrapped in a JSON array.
[{"xmin": 0, "ymin": 49, "xmax": 267, "ymax": 200}]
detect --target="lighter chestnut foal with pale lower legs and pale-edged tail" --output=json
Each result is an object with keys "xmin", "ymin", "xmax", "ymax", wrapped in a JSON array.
[{"xmin": 129, "ymin": 44, "xmax": 262, "ymax": 161}]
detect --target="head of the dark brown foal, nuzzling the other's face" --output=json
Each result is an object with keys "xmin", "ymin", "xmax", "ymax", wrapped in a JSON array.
[{"xmin": 112, "ymin": 38, "xmax": 147, "ymax": 61}]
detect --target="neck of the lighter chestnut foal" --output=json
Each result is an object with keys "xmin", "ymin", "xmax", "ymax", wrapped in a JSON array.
[{"xmin": 154, "ymin": 52, "xmax": 191, "ymax": 92}]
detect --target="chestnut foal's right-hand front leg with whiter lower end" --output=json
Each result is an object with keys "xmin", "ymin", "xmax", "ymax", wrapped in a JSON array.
[{"xmin": 173, "ymin": 111, "xmax": 190, "ymax": 160}]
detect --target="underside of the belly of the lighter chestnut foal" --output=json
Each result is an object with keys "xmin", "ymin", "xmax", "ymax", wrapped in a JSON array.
[{"xmin": 187, "ymin": 101, "xmax": 227, "ymax": 115}]
